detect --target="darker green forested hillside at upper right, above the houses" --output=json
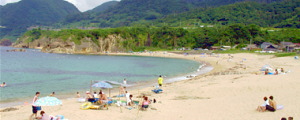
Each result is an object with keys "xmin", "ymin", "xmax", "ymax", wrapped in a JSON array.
[{"xmin": 151, "ymin": 0, "xmax": 300, "ymax": 28}]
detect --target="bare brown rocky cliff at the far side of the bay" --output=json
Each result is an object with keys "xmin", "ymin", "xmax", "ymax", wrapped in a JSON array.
[{"xmin": 13, "ymin": 35, "xmax": 125, "ymax": 54}]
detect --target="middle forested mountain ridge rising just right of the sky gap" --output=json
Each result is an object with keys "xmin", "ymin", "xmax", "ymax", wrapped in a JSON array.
[{"xmin": 63, "ymin": 0, "xmax": 282, "ymax": 27}]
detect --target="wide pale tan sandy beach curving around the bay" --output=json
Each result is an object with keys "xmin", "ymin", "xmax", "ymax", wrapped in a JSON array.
[{"xmin": 0, "ymin": 52, "xmax": 300, "ymax": 120}]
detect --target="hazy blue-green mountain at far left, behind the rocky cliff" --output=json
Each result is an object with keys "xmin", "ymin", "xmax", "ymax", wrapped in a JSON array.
[{"xmin": 0, "ymin": 0, "xmax": 80, "ymax": 38}]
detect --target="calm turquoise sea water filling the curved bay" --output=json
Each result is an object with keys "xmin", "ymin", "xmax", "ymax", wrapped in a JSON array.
[{"xmin": 0, "ymin": 47, "xmax": 200, "ymax": 107}]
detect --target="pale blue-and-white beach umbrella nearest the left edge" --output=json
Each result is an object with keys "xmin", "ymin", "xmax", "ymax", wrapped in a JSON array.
[{"xmin": 34, "ymin": 96, "xmax": 62, "ymax": 106}]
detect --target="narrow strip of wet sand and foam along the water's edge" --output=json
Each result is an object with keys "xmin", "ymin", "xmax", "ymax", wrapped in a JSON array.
[{"xmin": 0, "ymin": 52, "xmax": 213, "ymax": 110}]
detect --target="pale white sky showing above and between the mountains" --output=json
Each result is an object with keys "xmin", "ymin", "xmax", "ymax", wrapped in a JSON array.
[{"xmin": 0, "ymin": 0, "xmax": 120, "ymax": 12}]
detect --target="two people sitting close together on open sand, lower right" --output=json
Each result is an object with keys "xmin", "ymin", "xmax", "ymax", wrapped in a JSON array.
[{"xmin": 256, "ymin": 96, "xmax": 277, "ymax": 112}]
